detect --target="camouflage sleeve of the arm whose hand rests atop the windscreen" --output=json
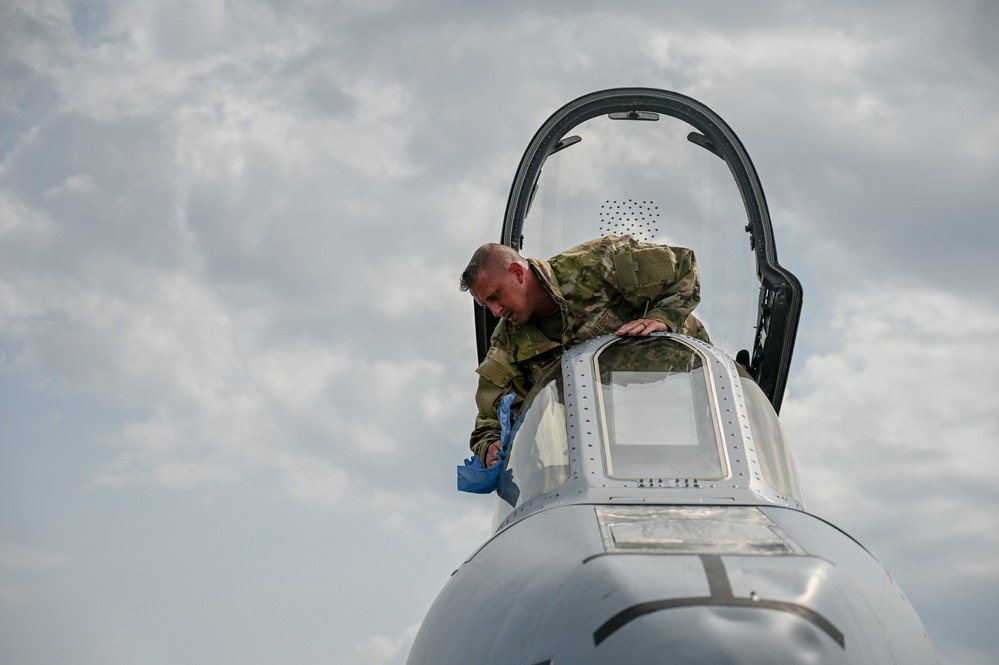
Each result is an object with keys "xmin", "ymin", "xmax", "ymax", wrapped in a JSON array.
[{"xmin": 613, "ymin": 238, "xmax": 701, "ymax": 332}]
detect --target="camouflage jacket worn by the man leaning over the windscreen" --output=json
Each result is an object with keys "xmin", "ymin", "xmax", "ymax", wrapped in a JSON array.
[{"xmin": 469, "ymin": 236, "xmax": 710, "ymax": 461}]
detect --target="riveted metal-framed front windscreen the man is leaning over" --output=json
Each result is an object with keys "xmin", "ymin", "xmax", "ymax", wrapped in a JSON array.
[{"xmin": 494, "ymin": 334, "xmax": 803, "ymax": 528}]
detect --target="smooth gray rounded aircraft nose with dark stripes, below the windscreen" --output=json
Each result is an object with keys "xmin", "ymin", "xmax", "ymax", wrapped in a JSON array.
[{"xmin": 409, "ymin": 505, "xmax": 936, "ymax": 665}]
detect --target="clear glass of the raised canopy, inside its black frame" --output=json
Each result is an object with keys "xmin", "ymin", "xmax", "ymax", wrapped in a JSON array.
[{"xmin": 522, "ymin": 114, "xmax": 759, "ymax": 356}]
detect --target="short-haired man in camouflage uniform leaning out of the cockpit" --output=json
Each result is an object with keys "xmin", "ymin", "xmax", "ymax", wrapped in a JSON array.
[{"xmin": 460, "ymin": 236, "xmax": 709, "ymax": 466}]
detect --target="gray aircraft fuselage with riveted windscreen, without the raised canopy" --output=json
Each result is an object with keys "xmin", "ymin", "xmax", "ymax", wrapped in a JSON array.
[{"xmin": 408, "ymin": 334, "xmax": 936, "ymax": 665}]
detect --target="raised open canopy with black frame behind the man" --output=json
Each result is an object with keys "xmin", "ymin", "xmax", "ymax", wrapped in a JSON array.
[{"xmin": 476, "ymin": 88, "xmax": 801, "ymax": 410}]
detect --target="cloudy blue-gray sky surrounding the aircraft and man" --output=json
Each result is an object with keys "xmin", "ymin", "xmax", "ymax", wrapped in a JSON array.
[{"xmin": 0, "ymin": 0, "xmax": 999, "ymax": 665}]
